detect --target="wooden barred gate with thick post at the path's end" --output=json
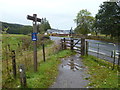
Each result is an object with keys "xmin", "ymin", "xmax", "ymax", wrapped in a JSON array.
[{"xmin": 61, "ymin": 38, "xmax": 88, "ymax": 56}]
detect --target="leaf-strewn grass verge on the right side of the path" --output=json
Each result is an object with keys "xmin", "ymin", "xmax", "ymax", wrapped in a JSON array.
[{"xmin": 83, "ymin": 56, "xmax": 118, "ymax": 88}]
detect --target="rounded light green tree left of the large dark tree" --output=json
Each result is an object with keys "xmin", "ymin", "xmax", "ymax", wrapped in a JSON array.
[{"xmin": 74, "ymin": 9, "xmax": 94, "ymax": 35}]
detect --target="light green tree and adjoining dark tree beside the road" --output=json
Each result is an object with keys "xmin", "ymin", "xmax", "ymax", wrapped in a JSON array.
[{"xmin": 74, "ymin": 2, "xmax": 120, "ymax": 38}]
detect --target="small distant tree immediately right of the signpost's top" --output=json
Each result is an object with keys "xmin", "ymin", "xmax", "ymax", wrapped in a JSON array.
[{"xmin": 38, "ymin": 18, "xmax": 51, "ymax": 33}]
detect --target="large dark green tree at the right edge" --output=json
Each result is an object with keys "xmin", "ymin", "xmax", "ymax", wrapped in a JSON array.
[{"xmin": 94, "ymin": 2, "xmax": 120, "ymax": 38}]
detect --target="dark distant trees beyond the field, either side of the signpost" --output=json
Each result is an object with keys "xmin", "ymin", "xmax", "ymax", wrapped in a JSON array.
[{"xmin": 2, "ymin": 18, "xmax": 51, "ymax": 35}]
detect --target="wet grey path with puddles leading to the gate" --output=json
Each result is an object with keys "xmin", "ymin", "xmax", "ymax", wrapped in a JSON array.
[{"xmin": 50, "ymin": 55, "xmax": 90, "ymax": 88}]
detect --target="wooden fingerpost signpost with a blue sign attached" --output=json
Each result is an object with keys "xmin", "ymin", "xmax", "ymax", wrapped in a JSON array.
[{"xmin": 27, "ymin": 14, "xmax": 41, "ymax": 72}]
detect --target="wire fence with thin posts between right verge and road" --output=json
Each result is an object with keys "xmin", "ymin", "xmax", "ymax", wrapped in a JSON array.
[{"xmin": 88, "ymin": 42, "xmax": 120, "ymax": 68}]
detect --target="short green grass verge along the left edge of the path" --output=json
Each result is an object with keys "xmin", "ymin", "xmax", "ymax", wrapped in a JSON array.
[{"xmin": 4, "ymin": 50, "xmax": 72, "ymax": 88}]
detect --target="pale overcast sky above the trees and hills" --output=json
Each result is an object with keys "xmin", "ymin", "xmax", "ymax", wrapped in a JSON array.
[{"xmin": 0, "ymin": 0, "xmax": 106, "ymax": 30}]
